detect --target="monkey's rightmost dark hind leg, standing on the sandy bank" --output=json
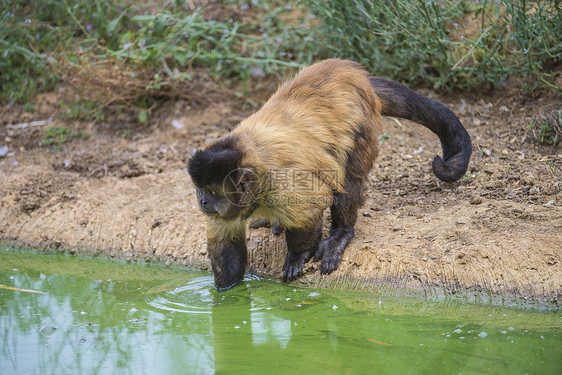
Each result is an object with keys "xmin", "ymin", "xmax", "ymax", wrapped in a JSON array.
[{"xmin": 314, "ymin": 179, "xmax": 363, "ymax": 275}]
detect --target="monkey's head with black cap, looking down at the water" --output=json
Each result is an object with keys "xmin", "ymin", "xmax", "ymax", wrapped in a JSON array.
[{"xmin": 187, "ymin": 137, "xmax": 258, "ymax": 219}]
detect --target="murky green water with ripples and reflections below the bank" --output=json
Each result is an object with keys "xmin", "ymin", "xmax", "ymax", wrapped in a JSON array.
[{"xmin": 0, "ymin": 251, "xmax": 562, "ymax": 375}]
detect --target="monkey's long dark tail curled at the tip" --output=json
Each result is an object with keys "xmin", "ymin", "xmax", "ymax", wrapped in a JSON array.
[{"xmin": 370, "ymin": 77, "xmax": 472, "ymax": 182}]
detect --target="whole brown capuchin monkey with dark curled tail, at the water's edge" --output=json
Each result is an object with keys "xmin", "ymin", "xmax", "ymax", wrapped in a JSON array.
[{"xmin": 188, "ymin": 59, "xmax": 472, "ymax": 290}]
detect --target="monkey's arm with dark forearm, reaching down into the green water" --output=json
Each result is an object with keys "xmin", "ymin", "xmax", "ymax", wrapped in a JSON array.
[{"xmin": 207, "ymin": 218, "xmax": 248, "ymax": 290}]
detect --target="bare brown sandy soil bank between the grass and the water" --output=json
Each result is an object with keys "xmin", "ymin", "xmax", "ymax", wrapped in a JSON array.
[{"xmin": 0, "ymin": 85, "xmax": 562, "ymax": 306}]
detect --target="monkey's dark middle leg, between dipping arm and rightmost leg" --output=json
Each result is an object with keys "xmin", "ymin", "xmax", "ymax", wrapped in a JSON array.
[{"xmin": 283, "ymin": 217, "xmax": 322, "ymax": 282}]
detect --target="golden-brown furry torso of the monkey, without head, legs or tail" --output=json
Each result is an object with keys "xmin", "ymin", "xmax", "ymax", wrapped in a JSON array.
[{"xmin": 228, "ymin": 59, "xmax": 381, "ymax": 228}]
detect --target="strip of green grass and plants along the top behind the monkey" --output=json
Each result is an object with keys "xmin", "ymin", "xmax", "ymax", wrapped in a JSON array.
[{"xmin": 0, "ymin": 0, "xmax": 562, "ymax": 106}]
